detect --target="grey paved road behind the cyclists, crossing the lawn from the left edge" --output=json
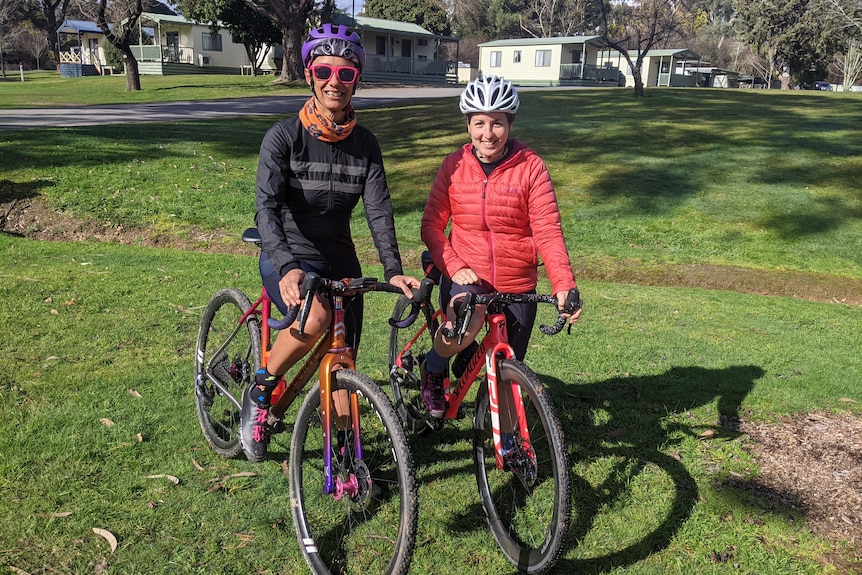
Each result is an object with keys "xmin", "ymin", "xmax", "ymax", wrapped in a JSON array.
[{"xmin": 0, "ymin": 87, "xmax": 462, "ymax": 130}]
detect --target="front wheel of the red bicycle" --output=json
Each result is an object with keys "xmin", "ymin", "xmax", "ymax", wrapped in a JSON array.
[{"xmin": 473, "ymin": 360, "xmax": 572, "ymax": 573}]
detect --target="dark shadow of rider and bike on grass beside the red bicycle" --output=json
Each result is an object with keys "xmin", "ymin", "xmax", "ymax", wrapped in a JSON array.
[{"xmin": 538, "ymin": 365, "xmax": 764, "ymax": 574}]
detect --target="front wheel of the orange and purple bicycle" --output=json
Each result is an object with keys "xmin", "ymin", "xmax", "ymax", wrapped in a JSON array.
[{"xmin": 290, "ymin": 369, "xmax": 418, "ymax": 575}]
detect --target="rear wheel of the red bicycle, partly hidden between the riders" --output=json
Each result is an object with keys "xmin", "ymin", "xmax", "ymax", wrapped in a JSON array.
[{"xmin": 389, "ymin": 296, "xmax": 437, "ymax": 434}]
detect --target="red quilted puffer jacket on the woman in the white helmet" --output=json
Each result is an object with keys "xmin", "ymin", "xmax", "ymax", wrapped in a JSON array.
[{"xmin": 421, "ymin": 140, "xmax": 575, "ymax": 293}]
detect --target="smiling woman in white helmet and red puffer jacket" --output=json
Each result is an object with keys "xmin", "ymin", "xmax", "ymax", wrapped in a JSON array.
[{"xmin": 421, "ymin": 76, "xmax": 581, "ymax": 417}]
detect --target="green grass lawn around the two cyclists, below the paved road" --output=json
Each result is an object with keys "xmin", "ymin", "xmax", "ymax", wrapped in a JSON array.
[{"xmin": 0, "ymin": 77, "xmax": 862, "ymax": 575}]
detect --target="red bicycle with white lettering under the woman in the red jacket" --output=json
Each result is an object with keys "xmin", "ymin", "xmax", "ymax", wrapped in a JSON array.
[{"xmin": 389, "ymin": 252, "xmax": 581, "ymax": 573}]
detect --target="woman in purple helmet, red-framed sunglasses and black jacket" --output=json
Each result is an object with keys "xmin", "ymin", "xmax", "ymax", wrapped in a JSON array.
[{"xmin": 240, "ymin": 24, "xmax": 419, "ymax": 461}]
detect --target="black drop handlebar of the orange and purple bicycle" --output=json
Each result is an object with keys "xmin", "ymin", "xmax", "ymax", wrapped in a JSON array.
[{"xmin": 267, "ymin": 272, "xmax": 434, "ymax": 334}]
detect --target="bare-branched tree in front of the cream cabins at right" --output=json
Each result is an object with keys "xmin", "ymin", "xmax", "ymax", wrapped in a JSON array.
[{"xmin": 600, "ymin": 0, "xmax": 692, "ymax": 98}]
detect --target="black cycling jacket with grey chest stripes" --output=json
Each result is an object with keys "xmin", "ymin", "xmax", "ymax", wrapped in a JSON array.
[{"xmin": 255, "ymin": 117, "xmax": 402, "ymax": 280}]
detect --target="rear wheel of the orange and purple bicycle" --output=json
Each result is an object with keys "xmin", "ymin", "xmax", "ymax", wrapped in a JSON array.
[{"xmin": 195, "ymin": 288, "xmax": 261, "ymax": 457}]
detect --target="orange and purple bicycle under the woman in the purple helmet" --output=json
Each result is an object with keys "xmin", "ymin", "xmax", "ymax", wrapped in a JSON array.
[{"xmin": 195, "ymin": 228, "xmax": 426, "ymax": 575}]
